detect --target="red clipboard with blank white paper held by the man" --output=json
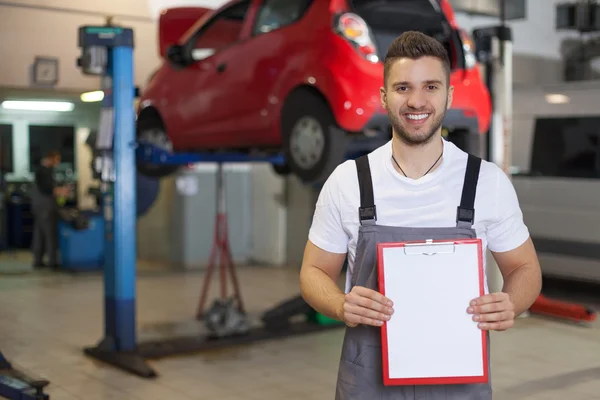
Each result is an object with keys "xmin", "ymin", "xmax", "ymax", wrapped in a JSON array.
[{"xmin": 377, "ymin": 239, "xmax": 489, "ymax": 386}]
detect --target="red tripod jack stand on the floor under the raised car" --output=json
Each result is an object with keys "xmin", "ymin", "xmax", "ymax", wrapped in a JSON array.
[{"xmin": 196, "ymin": 163, "xmax": 245, "ymax": 320}]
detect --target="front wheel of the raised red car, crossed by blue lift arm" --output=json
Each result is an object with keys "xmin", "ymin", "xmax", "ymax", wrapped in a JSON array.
[{"xmin": 136, "ymin": 112, "xmax": 180, "ymax": 178}]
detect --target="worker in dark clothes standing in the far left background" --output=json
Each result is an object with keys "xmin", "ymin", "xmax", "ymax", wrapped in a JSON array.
[{"xmin": 31, "ymin": 151, "xmax": 68, "ymax": 268}]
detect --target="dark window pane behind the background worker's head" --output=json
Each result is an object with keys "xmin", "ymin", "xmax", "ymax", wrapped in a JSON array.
[{"xmin": 29, "ymin": 125, "xmax": 75, "ymax": 171}]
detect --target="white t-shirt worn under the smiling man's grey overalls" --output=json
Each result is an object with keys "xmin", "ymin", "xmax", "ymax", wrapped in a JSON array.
[{"xmin": 308, "ymin": 140, "xmax": 529, "ymax": 293}]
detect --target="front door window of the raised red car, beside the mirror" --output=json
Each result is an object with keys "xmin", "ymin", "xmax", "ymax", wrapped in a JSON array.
[{"xmin": 194, "ymin": 1, "xmax": 250, "ymax": 51}]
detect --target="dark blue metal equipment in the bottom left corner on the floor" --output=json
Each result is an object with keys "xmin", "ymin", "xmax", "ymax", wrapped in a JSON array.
[{"xmin": 0, "ymin": 352, "xmax": 50, "ymax": 400}]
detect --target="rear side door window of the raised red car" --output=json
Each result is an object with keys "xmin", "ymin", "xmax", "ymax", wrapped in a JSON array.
[{"xmin": 253, "ymin": 0, "xmax": 312, "ymax": 35}]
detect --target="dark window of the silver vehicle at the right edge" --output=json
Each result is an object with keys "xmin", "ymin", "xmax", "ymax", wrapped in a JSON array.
[{"xmin": 531, "ymin": 117, "xmax": 600, "ymax": 179}]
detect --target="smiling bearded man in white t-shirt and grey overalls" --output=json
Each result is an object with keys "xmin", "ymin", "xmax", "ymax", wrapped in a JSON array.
[{"xmin": 300, "ymin": 32, "xmax": 541, "ymax": 400}]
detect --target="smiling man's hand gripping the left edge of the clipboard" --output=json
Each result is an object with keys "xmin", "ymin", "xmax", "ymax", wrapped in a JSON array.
[{"xmin": 343, "ymin": 286, "xmax": 394, "ymax": 327}]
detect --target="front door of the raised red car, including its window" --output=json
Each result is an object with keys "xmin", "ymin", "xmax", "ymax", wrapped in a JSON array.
[{"xmin": 178, "ymin": 0, "xmax": 252, "ymax": 144}]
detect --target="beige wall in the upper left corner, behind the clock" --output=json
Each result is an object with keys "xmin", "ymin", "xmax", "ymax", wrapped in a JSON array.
[{"xmin": 0, "ymin": 0, "xmax": 159, "ymax": 91}]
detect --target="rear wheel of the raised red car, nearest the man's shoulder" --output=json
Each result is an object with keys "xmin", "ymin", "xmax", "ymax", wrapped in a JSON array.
[{"xmin": 281, "ymin": 89, "xmax": 347, "ymax": 184}]
